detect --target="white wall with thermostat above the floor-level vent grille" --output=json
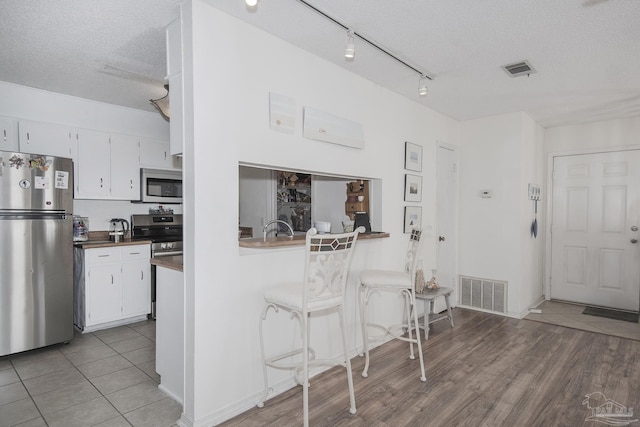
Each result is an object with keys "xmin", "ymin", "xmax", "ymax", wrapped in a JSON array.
[{"xmin": 458, "ymin": 113, "xmax": 544, "ymax": 317}]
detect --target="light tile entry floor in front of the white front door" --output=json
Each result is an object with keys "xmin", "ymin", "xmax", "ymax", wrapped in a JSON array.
[{"xmin": 525, "ymin": 301, "xmax": 640, "ymax": 341}]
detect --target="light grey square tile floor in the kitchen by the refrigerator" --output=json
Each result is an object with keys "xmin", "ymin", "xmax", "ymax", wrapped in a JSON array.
[{"xmin": 0, "ymin": 321, "xmax": 182, "ymax": 427}]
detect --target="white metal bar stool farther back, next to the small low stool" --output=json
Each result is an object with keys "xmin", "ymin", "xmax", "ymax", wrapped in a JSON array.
[{"xmin": 360, "ymin": 230, "xmax": 427, "ymax": 381}]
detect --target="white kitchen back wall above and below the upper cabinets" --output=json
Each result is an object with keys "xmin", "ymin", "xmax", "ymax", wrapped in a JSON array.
[{"xmin": 0, "ymin": 82, "xmax": 182, "ymax": 231}]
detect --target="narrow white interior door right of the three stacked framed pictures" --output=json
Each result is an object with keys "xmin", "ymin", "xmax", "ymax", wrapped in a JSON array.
[{"xmin": 438, "ymin": 145, "xmax": 458, "ymax": 296}]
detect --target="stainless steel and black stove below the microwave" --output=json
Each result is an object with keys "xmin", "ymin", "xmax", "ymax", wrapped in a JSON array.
[{"xmin": 131, "ymin": 214, "xmax": 182, "ymax": 319}]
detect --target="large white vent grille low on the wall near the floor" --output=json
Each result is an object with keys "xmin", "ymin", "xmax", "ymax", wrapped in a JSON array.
[{"xmin": 460, "ymin": 276, "xmax": 507, "ymax": 314}]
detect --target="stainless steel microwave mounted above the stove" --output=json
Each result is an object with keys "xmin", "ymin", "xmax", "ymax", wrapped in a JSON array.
[{"xmin": 140, "ymin": 169, "xmax": 182, "ymax": 203}]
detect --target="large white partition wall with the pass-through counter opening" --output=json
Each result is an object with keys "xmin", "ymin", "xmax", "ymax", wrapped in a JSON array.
[{"xmin": 183, "ymin": 0, "xmax": 458, "ymax": 425}]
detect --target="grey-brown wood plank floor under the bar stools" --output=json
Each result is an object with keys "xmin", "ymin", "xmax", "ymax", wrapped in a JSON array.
[{"xmin": 222, "ymin": 309, "xmax": 640, "ymax": 427}]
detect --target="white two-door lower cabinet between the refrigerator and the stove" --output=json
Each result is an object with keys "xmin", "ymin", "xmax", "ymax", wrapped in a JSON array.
[{"xmin": 74, "ymin": 244, "xmax": 151, "ymax": 332}]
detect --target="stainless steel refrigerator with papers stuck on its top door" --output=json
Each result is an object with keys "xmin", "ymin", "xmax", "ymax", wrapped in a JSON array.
[{"xmin": 0, "ymin": 151, "xmax": 73, "ymax": 356}]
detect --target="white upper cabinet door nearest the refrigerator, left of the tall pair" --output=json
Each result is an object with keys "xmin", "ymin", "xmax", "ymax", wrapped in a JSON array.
[{"xmin": 74, "ymin": 129, "xmax": 111, "ymax": 199}]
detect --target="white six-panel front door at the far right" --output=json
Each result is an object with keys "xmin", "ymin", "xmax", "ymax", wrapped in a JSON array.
[{"xmin": 551, "ymin": 150, "xmax": 640, "ymax": 311}]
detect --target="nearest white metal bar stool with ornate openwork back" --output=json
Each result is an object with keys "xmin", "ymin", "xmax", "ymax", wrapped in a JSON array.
[{"xmin": 258, "ymin": 227, "xmax": 364, "ymax": 427}]
